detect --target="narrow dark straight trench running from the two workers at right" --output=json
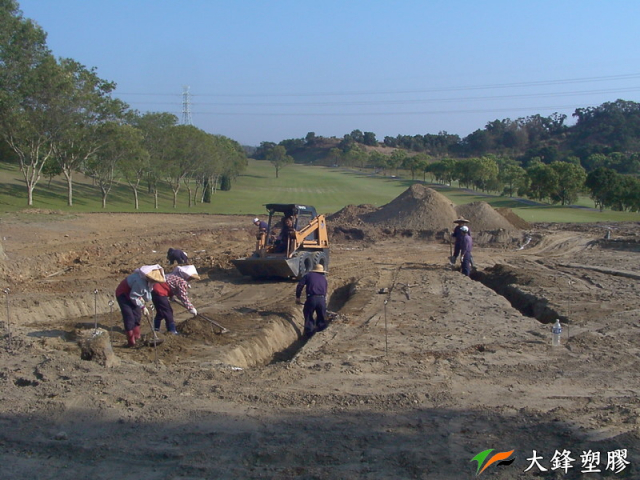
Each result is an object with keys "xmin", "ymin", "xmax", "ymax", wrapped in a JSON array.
[{"xmin": 471, "ymin": 264, "xmax": 568, "ymax": 324}]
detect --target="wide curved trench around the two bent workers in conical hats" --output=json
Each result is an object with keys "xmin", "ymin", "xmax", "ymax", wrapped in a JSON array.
[{"xmin": 58, "ymin": 283, "xmax": 355, "ymax": 369}]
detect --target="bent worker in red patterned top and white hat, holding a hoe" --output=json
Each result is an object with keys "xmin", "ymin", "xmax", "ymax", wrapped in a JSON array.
[{"xmin": 151, "ymin": 265, "xmax": 200, "ymax": 335}]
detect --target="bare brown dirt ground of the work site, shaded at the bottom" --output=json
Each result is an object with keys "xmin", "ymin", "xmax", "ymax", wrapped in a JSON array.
[{"xmin": 0, "ymin": 209, "xmax": 640, "ymax": 480}]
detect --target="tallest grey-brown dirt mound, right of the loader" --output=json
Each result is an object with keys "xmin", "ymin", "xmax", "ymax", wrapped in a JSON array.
[{"xmin": 361, "ymin": 183, "xmax": 457, "ymax": 231}]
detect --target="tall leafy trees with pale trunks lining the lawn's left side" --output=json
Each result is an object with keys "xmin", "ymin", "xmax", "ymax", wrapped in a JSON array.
[{"xmin": 0, "ymin": 0, "xmax": 247, "ymax": 209}]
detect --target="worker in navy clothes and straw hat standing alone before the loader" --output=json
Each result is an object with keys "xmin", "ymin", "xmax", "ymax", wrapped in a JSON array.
[{"xmin": 296, "ymin": 264, "xmax": 328, "ymax": 338}]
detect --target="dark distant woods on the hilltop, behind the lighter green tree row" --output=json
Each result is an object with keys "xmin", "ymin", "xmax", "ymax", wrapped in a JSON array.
[{"xmin": 272, "ymin": 100, "xmax": 640, "ymax": 180}]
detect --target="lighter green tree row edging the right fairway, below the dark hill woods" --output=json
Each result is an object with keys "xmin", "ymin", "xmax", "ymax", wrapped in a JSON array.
[{"xmin": 261, "ymin": 135, "xmax": 640, "ymax": 211}]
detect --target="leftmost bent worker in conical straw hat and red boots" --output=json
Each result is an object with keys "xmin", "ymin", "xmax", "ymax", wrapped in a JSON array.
[{"xmin": 116, "ymin": 265, "xmax": 165, "ymax": 347}]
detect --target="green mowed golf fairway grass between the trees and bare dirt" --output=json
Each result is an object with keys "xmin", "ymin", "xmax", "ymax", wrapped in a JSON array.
[{"xmin": 0, "ymin": 160, "xmax": 640, "ymax": 222}]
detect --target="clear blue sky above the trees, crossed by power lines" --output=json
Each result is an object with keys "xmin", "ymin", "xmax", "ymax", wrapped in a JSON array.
[{"xmin": 18, "ymin": 0, "xmax": 640, "ymax": 145}]
